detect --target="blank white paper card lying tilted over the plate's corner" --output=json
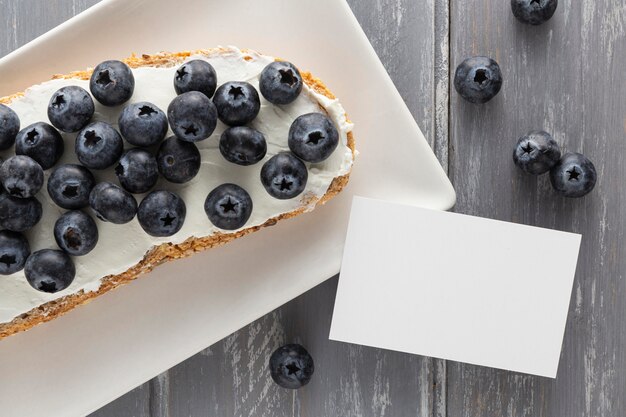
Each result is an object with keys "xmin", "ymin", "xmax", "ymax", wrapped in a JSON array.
[{"xmin": 330, "ymin": 197, "xmax": 581, "ymax": 378}]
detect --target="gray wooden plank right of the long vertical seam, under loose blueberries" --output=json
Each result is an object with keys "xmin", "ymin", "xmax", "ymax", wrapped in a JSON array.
[{"xmin": 447, "ymin": 0, "xmax": 626, "ymax": 417}]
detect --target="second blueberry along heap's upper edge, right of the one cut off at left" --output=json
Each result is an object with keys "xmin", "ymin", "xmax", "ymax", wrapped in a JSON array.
[{"xmin": 48, "ymin": 85, "xmax": 95, "ymax": 132}]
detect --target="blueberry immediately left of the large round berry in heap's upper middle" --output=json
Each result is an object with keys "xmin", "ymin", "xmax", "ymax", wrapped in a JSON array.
[{"xmin": 118, "ymin": 101, "xmax": 167, "ymax": 146}]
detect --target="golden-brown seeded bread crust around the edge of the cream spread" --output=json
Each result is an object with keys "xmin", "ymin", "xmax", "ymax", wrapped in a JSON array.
[{"xmin": 0, "ymin": 48, "xmax": 356, "ymax": 339}]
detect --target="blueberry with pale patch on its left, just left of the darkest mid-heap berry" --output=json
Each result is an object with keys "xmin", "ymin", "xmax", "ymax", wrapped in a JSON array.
[{"xmin": 115, "ymin": 148, "xmax": 159, "ymax": 193}]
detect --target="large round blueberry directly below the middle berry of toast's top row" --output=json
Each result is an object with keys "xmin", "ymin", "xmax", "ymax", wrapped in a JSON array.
[{"xmin": 167, "ymin": 91, "xmax": 217, "ymax": 142}]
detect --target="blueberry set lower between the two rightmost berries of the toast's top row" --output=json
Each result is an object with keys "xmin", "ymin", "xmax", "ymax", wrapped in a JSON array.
[{"xmin": 213, "ymin": 81, "xmax": 261, "ymax": 126}]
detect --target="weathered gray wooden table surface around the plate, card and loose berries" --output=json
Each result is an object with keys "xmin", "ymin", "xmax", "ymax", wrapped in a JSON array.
[{"xmin": 0, "ymin": 0, "xmax": 626, "ymax": 417}]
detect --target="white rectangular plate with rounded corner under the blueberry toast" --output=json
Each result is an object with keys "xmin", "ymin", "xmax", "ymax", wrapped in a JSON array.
[{"xmin": 0, "ymin": 0, "xmax": 455, "ymax": 417}]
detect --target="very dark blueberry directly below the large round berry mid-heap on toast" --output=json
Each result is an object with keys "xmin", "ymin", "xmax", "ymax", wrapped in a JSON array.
[{"xmin": 157, "ymin": 136, "xmax": 201, "ymax": 184}]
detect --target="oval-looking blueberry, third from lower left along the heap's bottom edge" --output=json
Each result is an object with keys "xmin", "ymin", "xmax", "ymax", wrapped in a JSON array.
[{"xmin": 89, "ymin": 182, "xmax": 137, "ymax": 224}]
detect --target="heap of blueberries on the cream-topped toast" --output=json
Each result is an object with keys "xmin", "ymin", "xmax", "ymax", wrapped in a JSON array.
[{"xmin": 0, "ymin": 56, "xmax": 339, "ymax": 293}]
